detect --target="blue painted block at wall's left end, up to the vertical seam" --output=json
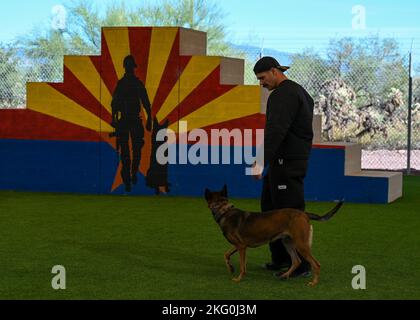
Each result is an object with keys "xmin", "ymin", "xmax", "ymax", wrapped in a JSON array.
[{"xmin": 0, "ymin": 140, "xmax": 100, "ymax": 193}]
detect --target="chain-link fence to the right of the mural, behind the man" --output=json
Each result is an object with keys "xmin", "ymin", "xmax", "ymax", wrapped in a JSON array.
[{"xmin": 241, "ymin": 45, "xmax": 420, "ymax": 171}]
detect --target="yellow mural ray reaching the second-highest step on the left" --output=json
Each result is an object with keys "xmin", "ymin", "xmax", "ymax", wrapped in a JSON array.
[{"xmin": 64, "ymin": 56, "xmax": 112, "ymax": 113}]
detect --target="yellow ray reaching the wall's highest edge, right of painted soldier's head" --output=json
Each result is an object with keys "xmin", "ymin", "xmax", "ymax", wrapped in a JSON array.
[{"xmin": 146, "ymin": 27, "xmax": 178, "ymax": 107}]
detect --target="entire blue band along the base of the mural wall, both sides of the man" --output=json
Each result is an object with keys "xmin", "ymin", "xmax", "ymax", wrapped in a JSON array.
[{"xmin": 0, "ymin": 140, "xmax": 388, "ymax": 203}]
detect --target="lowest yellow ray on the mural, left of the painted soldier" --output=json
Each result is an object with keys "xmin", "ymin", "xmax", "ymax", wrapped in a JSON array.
[{"xmin": 27, "ymin": 83, "xmax": 113, "ymax": 132}]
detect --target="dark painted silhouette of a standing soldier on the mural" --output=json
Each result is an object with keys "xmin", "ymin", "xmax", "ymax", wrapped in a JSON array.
[{"xmin": 111, "ymin": 55, "xmax": 152, "ymax": 192}]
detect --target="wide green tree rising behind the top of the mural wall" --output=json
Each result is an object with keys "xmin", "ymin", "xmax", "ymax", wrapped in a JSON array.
[{"xmin": 19, "ymin": 0, "xmax": 244, "ymax": 80}]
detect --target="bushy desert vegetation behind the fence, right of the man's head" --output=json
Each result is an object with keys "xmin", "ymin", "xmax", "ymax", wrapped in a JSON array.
[{"xmin": 289, "ymin": 36, "xmax": 408, "ymax": 147}]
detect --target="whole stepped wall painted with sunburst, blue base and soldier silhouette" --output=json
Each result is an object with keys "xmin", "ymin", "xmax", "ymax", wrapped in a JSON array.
[{"xmin": 0, "ymin": 27, "xmax": 401, "ymax": 202}]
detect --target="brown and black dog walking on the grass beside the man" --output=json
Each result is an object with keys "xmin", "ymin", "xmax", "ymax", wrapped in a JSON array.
[{"xmin": 205, "ymin": 185, "xmax": 343, "ymax": 286}]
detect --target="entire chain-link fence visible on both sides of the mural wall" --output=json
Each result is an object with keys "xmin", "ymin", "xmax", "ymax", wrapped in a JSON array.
[{"xmin": 0, "ymin": 39, "xmax": 420, "ymax": 170}]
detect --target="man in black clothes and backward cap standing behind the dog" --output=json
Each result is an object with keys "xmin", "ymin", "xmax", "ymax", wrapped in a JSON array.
[{"xmin": 254, "ymin": 57, "xmax": 314, "ymax": 277}]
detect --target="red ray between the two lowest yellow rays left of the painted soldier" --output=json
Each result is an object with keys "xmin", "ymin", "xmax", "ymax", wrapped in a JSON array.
[{"xmin": 48, "ymin": 66, "xmax": 112, "ymax": 123}]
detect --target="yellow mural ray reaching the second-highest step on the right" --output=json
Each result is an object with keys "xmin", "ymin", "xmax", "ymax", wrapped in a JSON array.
[{"xmin": 156, "ymin": 56, "xmax": 220, "ymax": 121}]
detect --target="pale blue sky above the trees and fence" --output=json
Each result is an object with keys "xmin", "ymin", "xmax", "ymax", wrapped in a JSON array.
[{"xmin": 0, "ymin": 0, "xmax": 420, "ymax": 69}]
